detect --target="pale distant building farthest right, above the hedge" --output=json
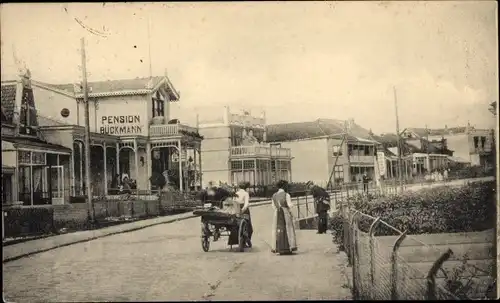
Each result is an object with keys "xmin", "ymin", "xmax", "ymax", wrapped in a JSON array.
[{"xmin": 403, "ymin": 125, "xmax": 495, "ymax": 168}]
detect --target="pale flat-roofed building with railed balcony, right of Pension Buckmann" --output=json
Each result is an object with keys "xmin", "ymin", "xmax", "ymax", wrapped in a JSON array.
[{"xmin": 198, "ymin": 107, "xmax": 292, "ymax": 186}]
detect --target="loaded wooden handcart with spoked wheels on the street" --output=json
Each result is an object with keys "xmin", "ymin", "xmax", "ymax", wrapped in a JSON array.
[{"xmin": 193, "ymin": 207, "xmax": 249, "ymax": 252}]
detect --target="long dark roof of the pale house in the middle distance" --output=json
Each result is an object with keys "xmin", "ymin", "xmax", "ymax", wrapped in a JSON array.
[{"xmin": 266, "ymin": 119, "xmax": 371, "ymax": 142}]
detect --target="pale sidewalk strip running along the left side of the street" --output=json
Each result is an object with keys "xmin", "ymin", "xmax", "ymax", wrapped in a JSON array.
[{"xmin": 2, "ymin": 200, "xmax": 270, "ymax": 262}]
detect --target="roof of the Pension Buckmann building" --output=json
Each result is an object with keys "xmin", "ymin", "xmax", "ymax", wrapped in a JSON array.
[{"xmin": 39, "ymin": 76, "xmax": 179, "ymax": 101}]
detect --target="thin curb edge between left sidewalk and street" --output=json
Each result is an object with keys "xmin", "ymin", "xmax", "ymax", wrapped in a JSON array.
[{"xmin": 2, "ymin": 200, "xmax": 271, "ymax": 263}]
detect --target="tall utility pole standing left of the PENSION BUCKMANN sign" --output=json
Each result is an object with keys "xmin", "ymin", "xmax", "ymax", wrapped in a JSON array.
[{"xmin": 81, "ymin": 38, "xmax": 94, "ymax": 223}]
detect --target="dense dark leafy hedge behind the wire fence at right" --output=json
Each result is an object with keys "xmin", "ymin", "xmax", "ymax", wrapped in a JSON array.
[{"xmin": 331, "ymin": 181, "xmax": 496, "ymax": 240}]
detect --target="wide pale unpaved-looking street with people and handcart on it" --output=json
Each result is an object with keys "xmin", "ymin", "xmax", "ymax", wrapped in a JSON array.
[{"xmin": 3, "ymin": 205, "xmax": 350, "ymax": 302}]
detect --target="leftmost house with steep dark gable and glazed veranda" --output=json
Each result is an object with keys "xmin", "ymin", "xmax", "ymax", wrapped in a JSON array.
[{"xmin": 1, "ymin": 71, "xmax": 72, "ymax": 205}]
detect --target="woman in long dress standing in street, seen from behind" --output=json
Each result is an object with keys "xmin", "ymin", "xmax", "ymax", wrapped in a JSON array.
[{"xmin": 271, "ymin": 180, "xmax": 297, "ymax": 255}]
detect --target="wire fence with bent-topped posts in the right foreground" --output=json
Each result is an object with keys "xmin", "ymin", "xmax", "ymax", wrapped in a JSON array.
[{"xmin": 339, "ymin": 203, "xmax": 496, "ymax": 300}]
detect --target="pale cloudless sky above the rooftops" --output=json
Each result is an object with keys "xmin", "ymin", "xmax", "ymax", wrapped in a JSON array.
[{"xmin": 0, "ymin": 1, "xmax": 499, "ymax": 133}]
